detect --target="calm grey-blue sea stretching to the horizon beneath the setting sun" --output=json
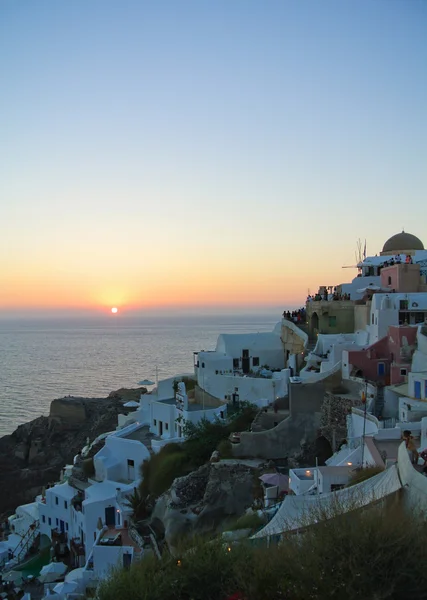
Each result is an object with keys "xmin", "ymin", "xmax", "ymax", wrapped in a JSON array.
[{"xmin": 0, "ymin": 311, "xmax": 280, "ymax": 437}]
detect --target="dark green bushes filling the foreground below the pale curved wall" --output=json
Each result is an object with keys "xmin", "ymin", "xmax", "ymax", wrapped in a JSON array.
[{"xmin": 98, "ymin": 504, "xmax": 427, "ymax": 600}]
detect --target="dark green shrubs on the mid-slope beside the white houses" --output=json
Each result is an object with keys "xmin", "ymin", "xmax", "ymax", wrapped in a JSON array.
[{"xmin": 139, "ymin": 403, "xmax": 257, "ymax": 498}]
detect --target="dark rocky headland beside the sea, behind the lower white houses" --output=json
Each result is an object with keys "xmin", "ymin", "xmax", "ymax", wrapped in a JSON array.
[{"xmin": 0, "ymin": 388, "xmax": 146, "ymax": 518}]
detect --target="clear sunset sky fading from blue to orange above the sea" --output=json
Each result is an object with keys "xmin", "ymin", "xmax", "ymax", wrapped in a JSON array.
[{"xmin": 0, "ymin": 0, "xmax": 427, "ymax": 316}]
